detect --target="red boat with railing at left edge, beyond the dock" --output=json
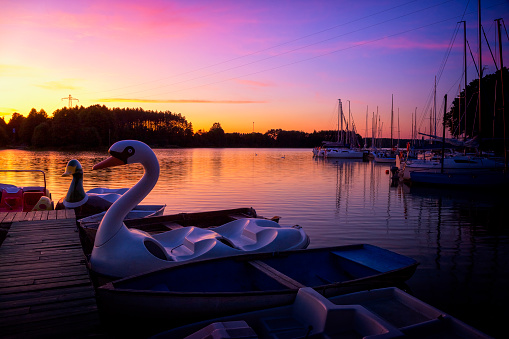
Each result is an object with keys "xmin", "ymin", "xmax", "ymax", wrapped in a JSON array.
[{"xmin": 0, "ymin": 170, "xmax": 53, "ymax": 212}]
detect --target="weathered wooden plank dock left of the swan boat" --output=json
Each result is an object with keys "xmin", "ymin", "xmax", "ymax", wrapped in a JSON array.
[{"xmin": 0, "ymin": 210, "xmax": 107, "ymax": 338}]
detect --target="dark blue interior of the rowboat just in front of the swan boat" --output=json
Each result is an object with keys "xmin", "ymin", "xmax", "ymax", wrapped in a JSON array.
[{"xmin": 107, "ymin": 247, "xmax": 412, "ymax": 293}]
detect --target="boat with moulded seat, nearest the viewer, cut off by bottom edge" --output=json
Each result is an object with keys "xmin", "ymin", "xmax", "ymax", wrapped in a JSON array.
[{"xmin": 160, "ymin": 287, "xmax": 489, "ymax": 339}]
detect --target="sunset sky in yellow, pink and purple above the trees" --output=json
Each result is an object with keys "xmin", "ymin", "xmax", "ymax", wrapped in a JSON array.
[{"xmin": 0, "ymin": 0, "xmax": 509, "ymax": 138}]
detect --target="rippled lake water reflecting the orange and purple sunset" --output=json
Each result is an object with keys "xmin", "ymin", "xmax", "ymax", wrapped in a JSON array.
[{"xmin": 0, "ymin": 149, "xmax": 509, "ymax": 337}]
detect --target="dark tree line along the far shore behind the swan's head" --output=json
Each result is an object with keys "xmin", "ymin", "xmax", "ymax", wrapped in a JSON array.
[{"xmin": 0, "ymin": 105, "xmax": 362, "ymax": 149}]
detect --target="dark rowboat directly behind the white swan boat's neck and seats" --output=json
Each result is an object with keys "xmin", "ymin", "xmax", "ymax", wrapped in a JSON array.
[{"xmin": 78, "ymin": 207, "xmax": 270, "ymax": 255}]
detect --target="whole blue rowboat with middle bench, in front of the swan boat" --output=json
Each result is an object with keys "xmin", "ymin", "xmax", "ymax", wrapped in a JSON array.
[{"xmin": 96, "ymin": 244, "xmax": 418, "ymax": 333}]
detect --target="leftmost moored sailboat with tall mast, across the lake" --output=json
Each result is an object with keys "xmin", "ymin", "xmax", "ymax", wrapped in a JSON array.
[{"xmin": 313, "ymin": 99, "xmax": 364, "ymax": 159}]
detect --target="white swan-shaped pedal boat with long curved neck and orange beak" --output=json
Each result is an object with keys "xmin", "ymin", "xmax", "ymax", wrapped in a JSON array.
[{"xmin": 90, "ymin": 140, "xmax": 309, "ymax": 277}]
